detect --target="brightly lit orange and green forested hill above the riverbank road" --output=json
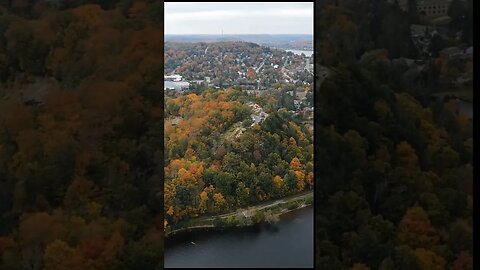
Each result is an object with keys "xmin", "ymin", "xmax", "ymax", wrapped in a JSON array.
[{"xmin": 165, "ymin": 88, "xmax": 313, "ymax": 229}]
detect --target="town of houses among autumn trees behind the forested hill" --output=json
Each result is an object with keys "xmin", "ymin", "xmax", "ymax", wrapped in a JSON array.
[{"xmin": 165, "ymin": 43, "xmax": 313, "ymax": 90}]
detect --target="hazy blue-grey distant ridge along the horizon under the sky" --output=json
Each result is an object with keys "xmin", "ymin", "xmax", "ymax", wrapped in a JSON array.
[{"xmin": 165, "ymin": 34, "xmax": 313, "ymax": 50}]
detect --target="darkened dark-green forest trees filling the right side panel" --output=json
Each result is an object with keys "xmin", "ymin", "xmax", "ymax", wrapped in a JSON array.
[{"xmin": 315, "ymin": 0, "xmax": 473, "ymax": 270}]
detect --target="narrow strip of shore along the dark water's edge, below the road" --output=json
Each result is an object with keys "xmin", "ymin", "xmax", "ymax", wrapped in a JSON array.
[{"xmin": 164, "ymin": 192, "xmax": 313, "ymax": 238}]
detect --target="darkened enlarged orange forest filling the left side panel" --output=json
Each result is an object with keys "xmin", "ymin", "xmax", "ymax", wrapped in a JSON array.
[{"xmin": 0, "ymin": 0, "xmax": 163, "ymax": 269}]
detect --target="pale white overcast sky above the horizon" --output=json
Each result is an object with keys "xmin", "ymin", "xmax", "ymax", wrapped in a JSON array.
[{"xmin": 165, "ymin": 2, "xmax": 313, "ymax": 35}]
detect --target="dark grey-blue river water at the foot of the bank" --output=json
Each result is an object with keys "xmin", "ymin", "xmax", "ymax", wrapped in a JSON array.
[{"xmin": 165, "ymin": 207, "xmax": 314, "ymax": 268}]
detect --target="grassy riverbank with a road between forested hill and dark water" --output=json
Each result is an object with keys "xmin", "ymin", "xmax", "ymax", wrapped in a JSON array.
[{"xmin": 165, "ymin": 191, "xmax": 313, "ymax": 238}]
